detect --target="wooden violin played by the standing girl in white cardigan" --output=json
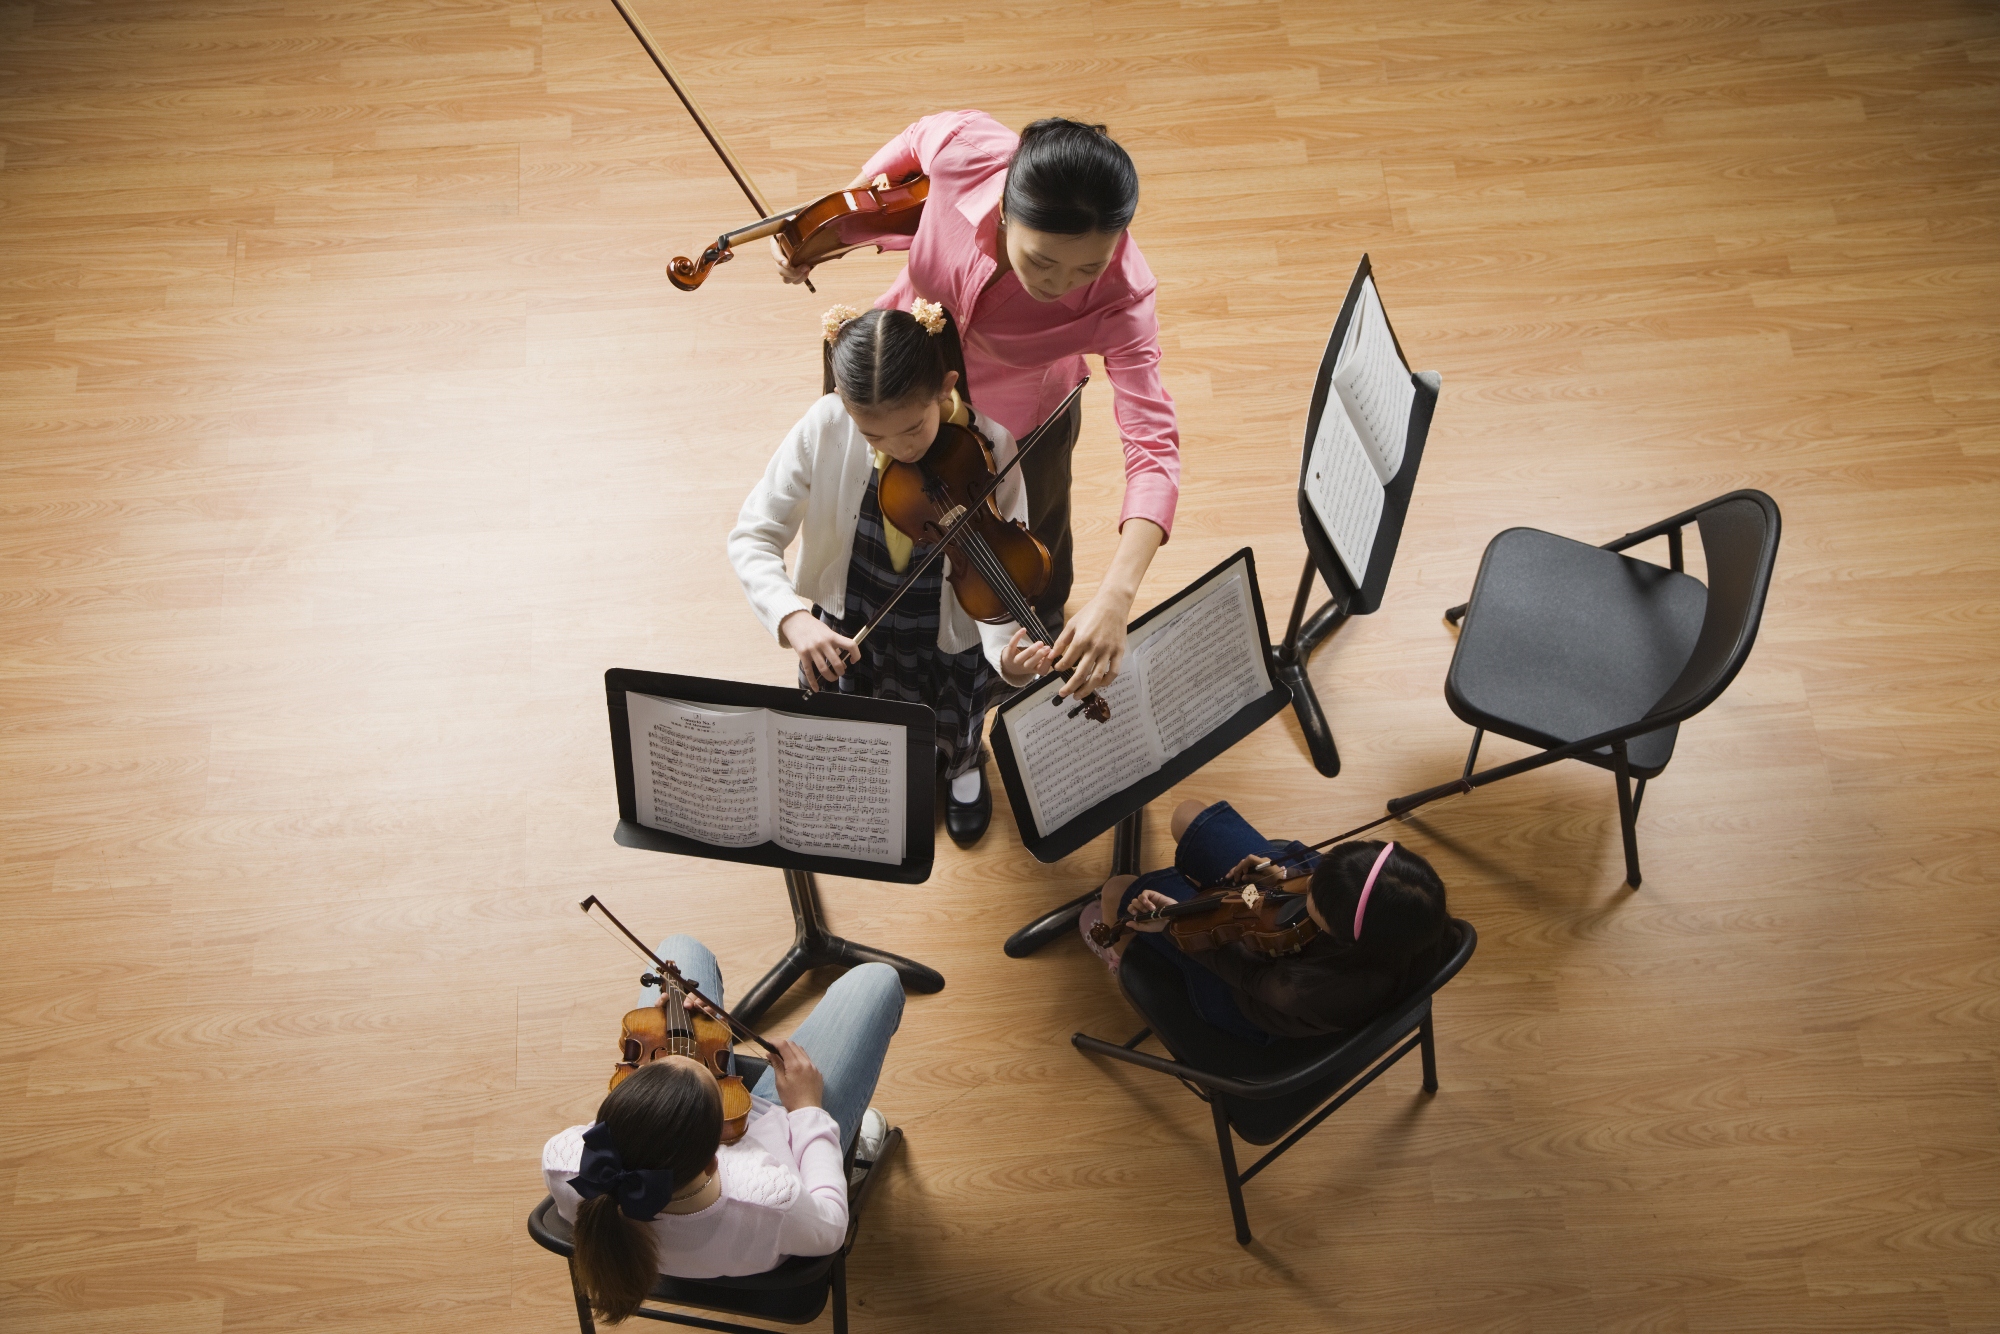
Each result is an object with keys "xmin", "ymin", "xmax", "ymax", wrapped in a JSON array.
[{"xmin": 876, "ymin": 422, "xmax": 1112, "ymax": 722}]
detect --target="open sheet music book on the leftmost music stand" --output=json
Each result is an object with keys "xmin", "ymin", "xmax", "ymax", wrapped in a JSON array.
[{"xmin": 626, "ymin": 690, "xmax": 908, "ymax": 866}]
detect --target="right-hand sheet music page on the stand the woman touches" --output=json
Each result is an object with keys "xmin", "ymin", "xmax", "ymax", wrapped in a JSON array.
[{"xmin": 1132, "ymin": 568, "xmax": 1272, "ymax": 768}]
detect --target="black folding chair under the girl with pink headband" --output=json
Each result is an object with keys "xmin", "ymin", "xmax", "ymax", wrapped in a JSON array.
[{"xmin": 1070, "ymin": 918, "xmax": 1480, "ymax": 1244}]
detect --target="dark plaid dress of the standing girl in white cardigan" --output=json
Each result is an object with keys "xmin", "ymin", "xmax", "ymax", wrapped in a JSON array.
[{"xmin": 800, "ymin": 474, "xmax": 1004, "ymax": 778}]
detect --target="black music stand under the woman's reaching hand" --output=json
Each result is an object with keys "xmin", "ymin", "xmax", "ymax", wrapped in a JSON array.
[{"xmin": 992, "ymin": 546, "xmax": 1292, "ymax": 958}]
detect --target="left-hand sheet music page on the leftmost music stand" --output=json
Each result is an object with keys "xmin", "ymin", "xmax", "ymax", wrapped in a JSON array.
[{"xmin": 626, "ymin": 690, "xmax": 770, "ymax": 848}]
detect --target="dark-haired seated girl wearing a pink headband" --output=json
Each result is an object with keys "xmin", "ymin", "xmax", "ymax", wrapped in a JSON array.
[{"xmin": 1078, "ymin": 802, "xmax": 1450, "ymax": 1044}]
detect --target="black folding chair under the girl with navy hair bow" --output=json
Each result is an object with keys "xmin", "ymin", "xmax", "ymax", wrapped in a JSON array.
[{"xmin": 528, "ymin": 1056, "xmax": 902, "ymax": 1334}]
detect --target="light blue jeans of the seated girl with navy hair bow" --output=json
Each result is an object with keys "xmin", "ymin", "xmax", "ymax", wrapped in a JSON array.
[{"xmin": 638, "ymin": 936, "xmax": 902, "ymax": 1152}]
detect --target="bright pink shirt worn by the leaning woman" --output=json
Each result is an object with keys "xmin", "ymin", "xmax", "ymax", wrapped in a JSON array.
[{"xmin": 862, "ymin": 112, "xmax": 1180, "ymax": 534}]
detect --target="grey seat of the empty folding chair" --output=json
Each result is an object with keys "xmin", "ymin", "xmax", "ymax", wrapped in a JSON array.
[{"xmin": 1444, "ymin": 528, "xmax": 1708, "ymax": 778}]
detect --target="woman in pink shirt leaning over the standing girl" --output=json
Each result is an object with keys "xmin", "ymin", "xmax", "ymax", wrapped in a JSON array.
[{"xmin": 774, "ymin": 112, "xmax": 1180, "ymax": 724}]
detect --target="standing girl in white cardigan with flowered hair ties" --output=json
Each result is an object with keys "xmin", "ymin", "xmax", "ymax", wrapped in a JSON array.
[{"xmin": 728, "ymin": 302, "xmax": 1054, "ymax": 846}]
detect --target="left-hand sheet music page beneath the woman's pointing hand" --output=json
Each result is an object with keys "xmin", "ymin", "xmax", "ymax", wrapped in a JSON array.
[{"xmin": 1006, "ymin": 670, "xmax": 1164, "ymax": 834}]
